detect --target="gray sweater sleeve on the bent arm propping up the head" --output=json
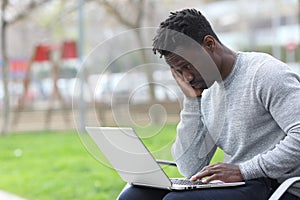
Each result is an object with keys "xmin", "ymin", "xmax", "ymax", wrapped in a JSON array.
[{"xmin": 172, "ymin": 97, "xmax": 216, "ymax": 177}]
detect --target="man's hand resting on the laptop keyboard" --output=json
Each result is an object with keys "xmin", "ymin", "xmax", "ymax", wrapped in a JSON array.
[{"xmin": 190, "ymin": 163, "xmax": 244, "ymax": 183}]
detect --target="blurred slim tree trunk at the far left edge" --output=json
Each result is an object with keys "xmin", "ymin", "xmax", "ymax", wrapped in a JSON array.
[{"xmin": 0, "ymin": 0, "xmax": 10, "ymax": 135}]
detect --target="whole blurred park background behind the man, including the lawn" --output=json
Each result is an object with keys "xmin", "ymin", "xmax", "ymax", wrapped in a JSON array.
[{"xmin": 0, "ymin": 0, "xmax": 300, "ymax": 199}]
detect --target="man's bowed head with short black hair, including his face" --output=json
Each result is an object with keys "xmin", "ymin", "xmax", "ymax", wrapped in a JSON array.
[{"xmin": 153, "ymin": 9, "xmax": 222, "ymax": 89}]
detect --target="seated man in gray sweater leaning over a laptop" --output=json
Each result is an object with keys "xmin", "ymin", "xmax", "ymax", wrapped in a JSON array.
[{"xmin": 120, "ymin": 9, "xmax": 300, "ymax": 200}]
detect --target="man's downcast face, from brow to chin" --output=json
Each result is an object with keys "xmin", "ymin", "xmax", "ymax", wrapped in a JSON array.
[{"xmin": 165, "ymin": 53, "xmax": 208, "ymax": 89}]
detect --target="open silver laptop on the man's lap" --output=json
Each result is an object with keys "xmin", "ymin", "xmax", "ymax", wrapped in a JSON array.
[{"xmin": 86, "ymin": 127, "xmax": 245, "ymax": 190}]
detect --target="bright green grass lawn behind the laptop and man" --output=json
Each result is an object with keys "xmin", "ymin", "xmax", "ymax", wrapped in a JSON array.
[{"xmin": 0, "ymin": 125, "xmax": 223, "ymax": 200}]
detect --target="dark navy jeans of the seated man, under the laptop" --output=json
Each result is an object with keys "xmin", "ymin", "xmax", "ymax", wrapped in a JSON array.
[{"xmin": 119, "ymin": 178, "xmax": 299, "ymax": 200}]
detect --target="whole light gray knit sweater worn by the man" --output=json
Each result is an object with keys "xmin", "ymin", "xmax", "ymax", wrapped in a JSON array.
[{"xmin": 172, "ymin": 52, "xmax": 300, "ymax": 197}]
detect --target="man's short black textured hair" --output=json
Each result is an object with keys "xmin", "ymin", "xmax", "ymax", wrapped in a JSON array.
[{"xmin": 153, "ymin": 9, "xmax": 221, "ymax": 57}]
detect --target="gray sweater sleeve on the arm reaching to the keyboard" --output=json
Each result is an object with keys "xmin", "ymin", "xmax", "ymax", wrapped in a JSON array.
[{"xmin": 240, "ymin": 66, "xmax": 300, "ymax": 180}]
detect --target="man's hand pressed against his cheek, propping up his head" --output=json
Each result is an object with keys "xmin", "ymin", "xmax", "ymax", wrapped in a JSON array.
[{"xmin": 171, "ymin": 69, "xmax": 203, "ymax": 98}]
